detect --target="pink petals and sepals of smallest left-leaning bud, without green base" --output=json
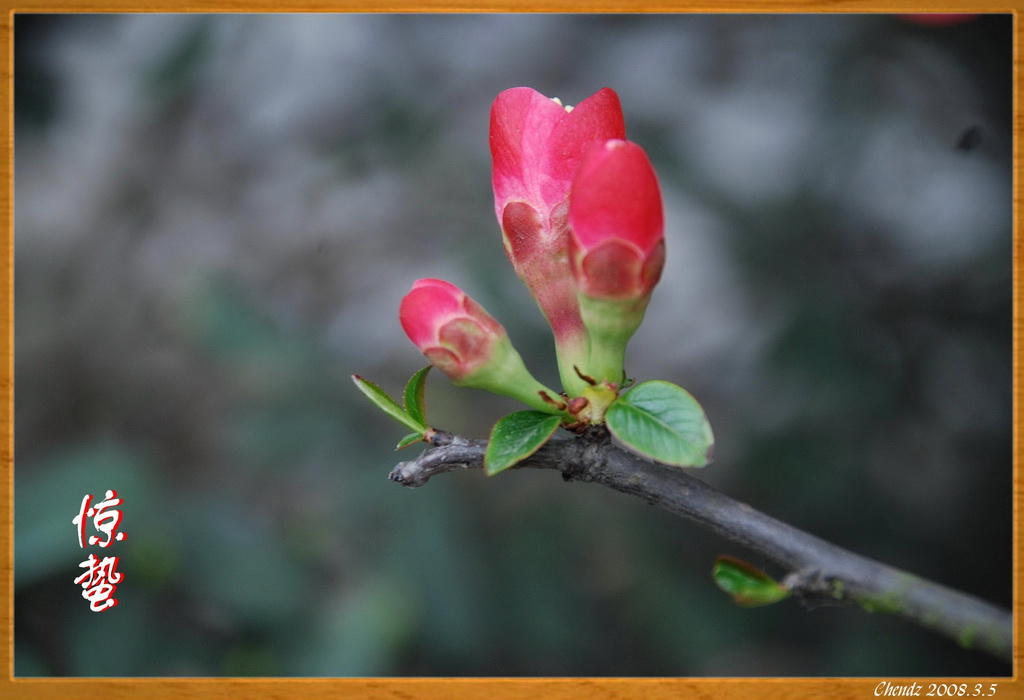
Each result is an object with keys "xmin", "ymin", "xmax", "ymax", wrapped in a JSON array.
[{"xmin": 398, "ymin": 279, "xmax": 506, "ymax": 383}]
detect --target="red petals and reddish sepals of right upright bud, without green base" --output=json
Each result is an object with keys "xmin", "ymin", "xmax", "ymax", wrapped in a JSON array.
[{"xmin": 569, "ymin": 139, "xmax": 665, "ymax": 301}]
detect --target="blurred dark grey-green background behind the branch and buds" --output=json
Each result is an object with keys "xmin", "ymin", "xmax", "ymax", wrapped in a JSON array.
[{"xmin": 14, "ymin": 14, "xmax": 1013, "ymax": 676}]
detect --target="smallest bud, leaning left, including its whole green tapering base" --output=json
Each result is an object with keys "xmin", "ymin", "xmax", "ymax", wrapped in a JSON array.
[{"xmin": 398, "ymin": 279, "xmax": 561, "ymax": 413}]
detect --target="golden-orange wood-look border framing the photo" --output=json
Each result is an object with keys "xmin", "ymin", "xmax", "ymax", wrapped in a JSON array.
[{"xmin": 0, "ymin": 6, "xmax": 1024, "ymax": 700}]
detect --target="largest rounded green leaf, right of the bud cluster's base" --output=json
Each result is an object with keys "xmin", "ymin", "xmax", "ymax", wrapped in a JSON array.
[{"xmin": 604, "ymin": 381, "xmax": 715, "ymax": 467}]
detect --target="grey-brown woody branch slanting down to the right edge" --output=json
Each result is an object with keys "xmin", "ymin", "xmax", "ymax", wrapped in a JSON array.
[{"xmin": 388, "ymin": 431, "xmax": 1013, "ymax": 662}]
